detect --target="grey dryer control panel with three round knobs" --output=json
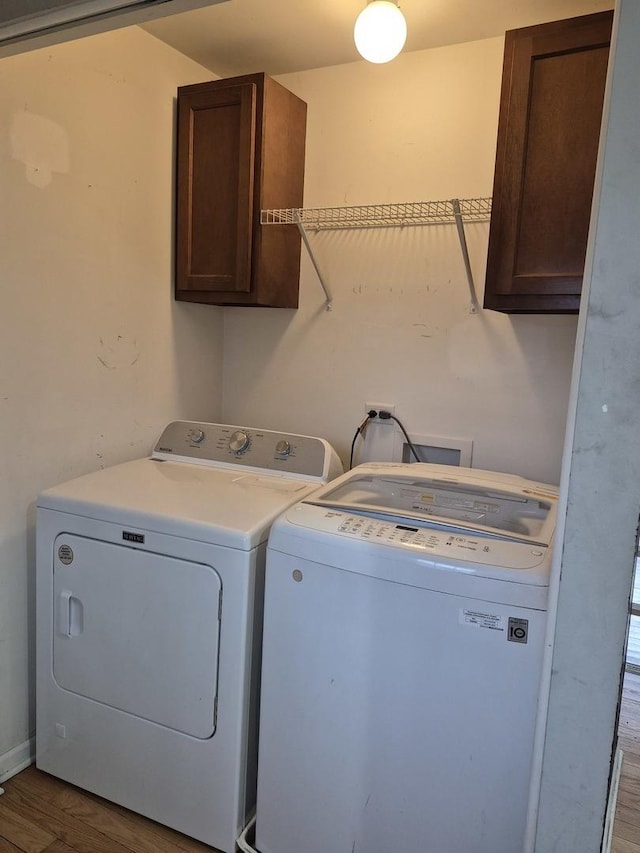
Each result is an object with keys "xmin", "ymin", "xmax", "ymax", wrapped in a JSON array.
[{"xmin": 152, "ymin": 421, "xmax": 332, "ymax": 477}]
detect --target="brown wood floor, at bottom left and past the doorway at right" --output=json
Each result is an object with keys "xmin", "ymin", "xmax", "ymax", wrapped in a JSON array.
[{"xmin": 0, "ymin": 684, "xmax": 640, "ymax": 853}]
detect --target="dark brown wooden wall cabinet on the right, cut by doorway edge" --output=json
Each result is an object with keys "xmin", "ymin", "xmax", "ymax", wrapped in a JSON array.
[{"xmin": 484, "ymin": 12, "xmax": 613, "ymax": 314}]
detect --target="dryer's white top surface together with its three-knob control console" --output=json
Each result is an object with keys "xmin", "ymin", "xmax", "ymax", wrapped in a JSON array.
[{"xmin": 38, "ymin": 421, "xmax": 342, "ymax": 550}]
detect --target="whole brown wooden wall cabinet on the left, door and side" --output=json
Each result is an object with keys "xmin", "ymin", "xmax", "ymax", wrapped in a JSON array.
[{"xmin": 175, "ymin": 74, "xmax": 307, "ymax": 308}]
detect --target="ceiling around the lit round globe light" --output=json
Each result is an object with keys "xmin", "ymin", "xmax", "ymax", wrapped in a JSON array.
[{"xmin": 144, "ymin": 0, "xmax": 614, "ymax": 77}]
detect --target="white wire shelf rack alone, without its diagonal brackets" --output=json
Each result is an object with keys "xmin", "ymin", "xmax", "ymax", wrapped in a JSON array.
[{"xmin": 260, "ymin": 198, "xmax": 491, "ymax": 231}]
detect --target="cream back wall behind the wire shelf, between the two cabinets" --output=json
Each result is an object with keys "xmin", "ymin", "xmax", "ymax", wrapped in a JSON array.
[{"xmin": 223, "ymin": 38, "xmax": 576, "ymax": 482}]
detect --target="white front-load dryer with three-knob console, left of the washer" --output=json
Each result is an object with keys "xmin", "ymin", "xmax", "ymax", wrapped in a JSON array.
[{"xmin": 36, "ymin": 422, "xmax": 342, "ymax": 853}]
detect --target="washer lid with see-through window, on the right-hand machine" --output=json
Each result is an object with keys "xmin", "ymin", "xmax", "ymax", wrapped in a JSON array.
[{"xmin": 307, "ymin": 463, "xmax": 558, "ymax": 546}]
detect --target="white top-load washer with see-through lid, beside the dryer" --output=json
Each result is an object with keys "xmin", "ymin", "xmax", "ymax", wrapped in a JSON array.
[{"xmin": 255, "ymin": 464, "xmax": 557, "ymax": 853}]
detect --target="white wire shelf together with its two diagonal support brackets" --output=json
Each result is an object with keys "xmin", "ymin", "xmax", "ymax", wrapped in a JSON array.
[{"xmin": 260, "ymin": 198, "xmax": 491, "ymax": 314}]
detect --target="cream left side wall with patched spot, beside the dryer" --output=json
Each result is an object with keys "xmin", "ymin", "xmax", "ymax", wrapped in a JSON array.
[{"xmin": 0, "ymin": 29, "xmax": 222, "ymax": 779}]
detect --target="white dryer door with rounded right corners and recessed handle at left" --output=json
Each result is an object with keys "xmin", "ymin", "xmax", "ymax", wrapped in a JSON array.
[{"xmin": 52, "ymin": 533, "xmax": 221, "ymax": 738}]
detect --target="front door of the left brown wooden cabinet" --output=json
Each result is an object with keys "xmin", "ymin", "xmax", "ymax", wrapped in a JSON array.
[{"xmin": 176, "ymin": 83, "xmax": 256, "ymax": 294}]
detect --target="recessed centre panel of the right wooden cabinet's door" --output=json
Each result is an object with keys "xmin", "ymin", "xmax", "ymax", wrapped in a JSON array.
[{"xmin": 514, "ymin": 48, "xmax": 608, "ymax": 284}]
